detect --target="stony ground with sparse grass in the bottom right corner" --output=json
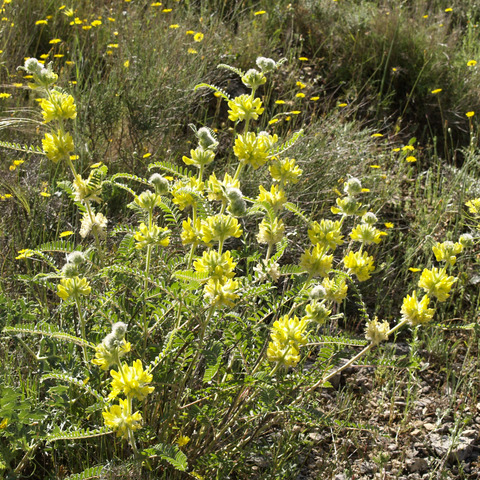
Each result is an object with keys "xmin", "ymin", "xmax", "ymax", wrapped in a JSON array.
[{"xmin": 297, "ymin": 342, "xmax": 480, "ymax": 480}]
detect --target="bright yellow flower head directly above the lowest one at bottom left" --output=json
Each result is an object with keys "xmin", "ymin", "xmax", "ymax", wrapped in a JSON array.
[{"xmin": 108, "ymin": 360, "xmax": 155, "ymax": 401}]
